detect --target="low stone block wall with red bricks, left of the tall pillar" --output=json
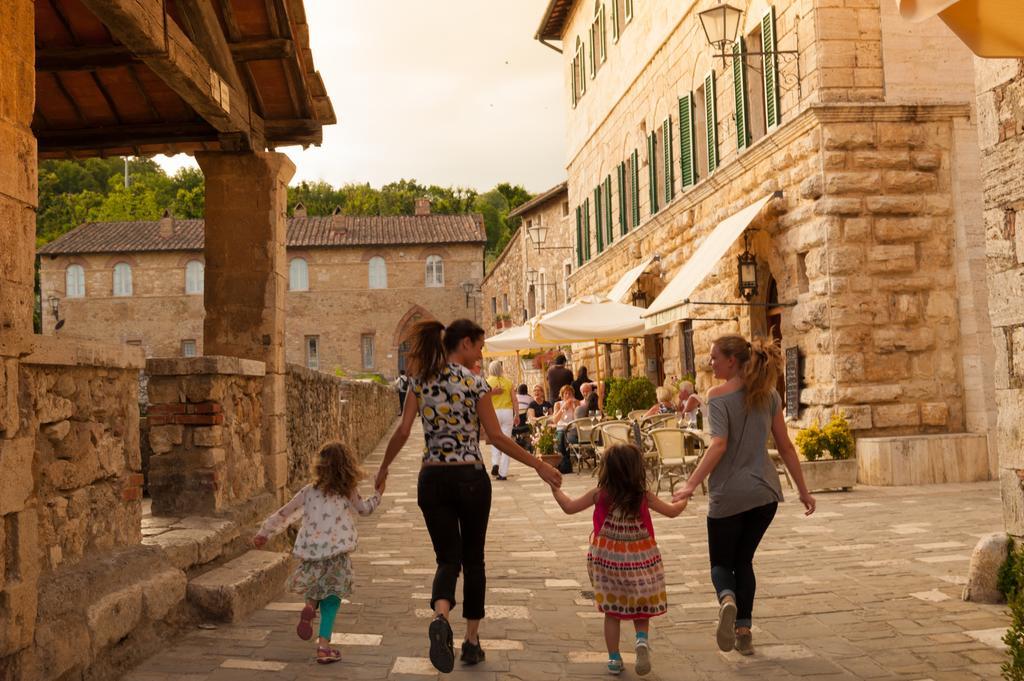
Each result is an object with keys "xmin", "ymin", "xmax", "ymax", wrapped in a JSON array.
[{"xmin": 146, "ymin": 356, "xmax": 270, "ymax": 516}]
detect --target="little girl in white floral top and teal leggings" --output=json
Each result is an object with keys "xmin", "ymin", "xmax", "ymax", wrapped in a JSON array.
[{"xmin": 253, "ymin": 442, "xmax": 384, "ymax": 665}]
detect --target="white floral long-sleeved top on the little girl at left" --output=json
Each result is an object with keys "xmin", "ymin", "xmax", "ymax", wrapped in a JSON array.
[{"xmin": 259, "ymin": 484, "xmax": 381, "ymax": 560}]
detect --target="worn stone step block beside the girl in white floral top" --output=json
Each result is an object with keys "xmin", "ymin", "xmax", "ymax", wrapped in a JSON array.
[{"xmin": 188, "ymin": 551, "xmax": 292, "ymax": 622}]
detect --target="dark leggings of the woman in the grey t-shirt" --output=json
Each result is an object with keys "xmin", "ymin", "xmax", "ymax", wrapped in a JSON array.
[{"xmin": 708, "ymin": 502, "xmax": 778, "ymax": 627}]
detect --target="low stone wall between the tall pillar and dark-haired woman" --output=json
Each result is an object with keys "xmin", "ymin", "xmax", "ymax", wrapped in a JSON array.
[{"xmin": 285, "ymin": 365, "xmax": 398, "ymax": 493}]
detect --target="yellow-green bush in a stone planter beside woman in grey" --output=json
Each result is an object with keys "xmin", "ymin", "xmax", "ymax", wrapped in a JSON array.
[{"xmin": 796, "ymin": 412, "xmax": 857, "ymax": 491}]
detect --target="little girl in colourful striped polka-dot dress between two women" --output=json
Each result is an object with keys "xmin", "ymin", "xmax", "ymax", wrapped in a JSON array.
[{"xmin": 551, "ymin": 444, "xmax": 686, "ymax": 676}]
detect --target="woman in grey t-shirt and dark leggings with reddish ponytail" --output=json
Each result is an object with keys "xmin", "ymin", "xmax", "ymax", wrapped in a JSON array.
[{"xmin": 672, "ymin": 335, "xmax": 815, "ymax": 655}]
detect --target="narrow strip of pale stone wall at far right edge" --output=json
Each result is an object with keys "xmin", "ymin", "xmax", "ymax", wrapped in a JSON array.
[{"xmin": 976, "ymin": 59, "xmax": 1024, "ymax": 537}]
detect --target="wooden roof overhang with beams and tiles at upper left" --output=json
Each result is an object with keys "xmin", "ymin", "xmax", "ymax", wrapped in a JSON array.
[{"xmin": 32, "ymin": 0, "xmax": 336, "ymax": 159}]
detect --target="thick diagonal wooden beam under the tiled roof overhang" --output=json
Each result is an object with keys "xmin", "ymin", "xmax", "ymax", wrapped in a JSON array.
[{"xmin": 82, "ymin": 0, "xmax": 264, "ymax": 150}]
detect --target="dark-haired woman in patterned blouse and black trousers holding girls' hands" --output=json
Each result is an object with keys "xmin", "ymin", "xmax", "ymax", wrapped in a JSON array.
[{"xmin": 376, "ymin": 320, "xmax": 561, "ymax": 673}]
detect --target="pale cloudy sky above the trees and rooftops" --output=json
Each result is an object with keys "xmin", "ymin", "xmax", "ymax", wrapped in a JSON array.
[{"xmin": 157, "ymin": 0, "xmax": 566, "ymax": 193}]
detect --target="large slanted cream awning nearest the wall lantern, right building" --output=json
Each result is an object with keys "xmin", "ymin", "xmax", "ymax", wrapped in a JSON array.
[{"xmin": 643, "ymin": 191, "xmax": 781, "ymax": 331}]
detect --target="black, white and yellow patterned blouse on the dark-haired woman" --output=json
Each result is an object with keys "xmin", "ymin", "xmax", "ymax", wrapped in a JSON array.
[{"xmin": 413, "ymin": 363, "xmax": 490, "ymax": 464}]
